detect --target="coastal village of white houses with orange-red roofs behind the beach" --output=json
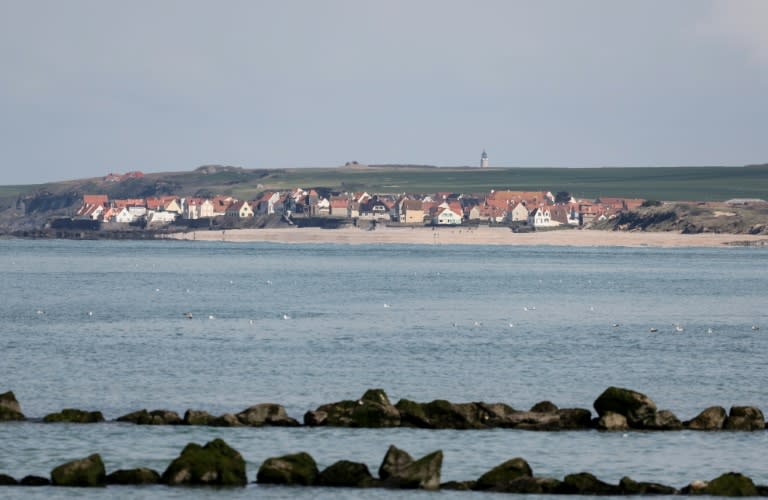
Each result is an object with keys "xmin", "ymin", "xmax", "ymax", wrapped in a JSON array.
[{"xmin": 73, "ymin": 188, "xmax": 645, "ymax": 229}]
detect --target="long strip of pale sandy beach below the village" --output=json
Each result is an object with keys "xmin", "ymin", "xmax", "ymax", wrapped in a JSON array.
[{"xmin": 166, "ymin": 226, "xmax": 768, "ymax": 248}]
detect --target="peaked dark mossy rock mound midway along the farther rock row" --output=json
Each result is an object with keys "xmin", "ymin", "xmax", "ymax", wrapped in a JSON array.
[{"xmin": 304, "ymin": 389, "xmax": 400, "ymax": 427}]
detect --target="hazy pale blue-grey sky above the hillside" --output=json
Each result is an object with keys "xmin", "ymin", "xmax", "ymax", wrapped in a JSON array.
[{"xmin": 0, "ymin": 0, "xmax": 768, "ymax": 185}]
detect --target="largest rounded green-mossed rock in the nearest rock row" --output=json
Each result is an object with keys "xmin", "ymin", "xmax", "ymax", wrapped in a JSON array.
[{"xmin": 161, "ymin": 439, "xmax": 248, "ymax": 486}]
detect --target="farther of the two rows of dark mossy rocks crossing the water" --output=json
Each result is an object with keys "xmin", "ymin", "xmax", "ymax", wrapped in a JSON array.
[{"xmin": 0, "ymin": 387, "xmax": 767, "ymax": 431}]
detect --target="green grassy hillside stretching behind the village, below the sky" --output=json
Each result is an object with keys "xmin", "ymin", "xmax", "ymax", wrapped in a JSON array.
[{"xmin": 0, "ymin": 165, "xmax": 768, "ymax": 201}]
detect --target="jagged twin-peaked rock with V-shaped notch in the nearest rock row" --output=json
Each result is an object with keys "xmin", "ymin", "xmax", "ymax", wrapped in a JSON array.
[{"xmin": 379, "ymin": 445, "xmax": 443, "ymax": 490}]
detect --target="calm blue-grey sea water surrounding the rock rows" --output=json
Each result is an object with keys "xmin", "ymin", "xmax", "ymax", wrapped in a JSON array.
[{"xmin": 0, "ymin": 240, "xmax": 768, "ymax": 499}]
